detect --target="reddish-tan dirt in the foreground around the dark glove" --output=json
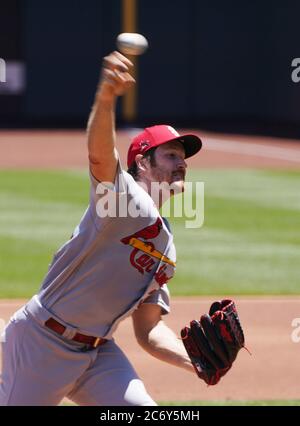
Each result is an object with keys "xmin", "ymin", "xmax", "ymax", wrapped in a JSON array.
[{"xmin": 0, "ymin": 297, "xmax": 300, "ymax": 401}]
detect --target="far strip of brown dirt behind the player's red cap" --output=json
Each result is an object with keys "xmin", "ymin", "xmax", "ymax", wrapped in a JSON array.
[{"xmin": 0, "ymin": 129, "xmax": 300, "ymax": 169}]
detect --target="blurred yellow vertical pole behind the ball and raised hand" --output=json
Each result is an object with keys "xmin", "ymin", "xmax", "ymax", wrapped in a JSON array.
[{"xmin": 122, "ymin": 0, "xmax": 138, "ymax": 122}]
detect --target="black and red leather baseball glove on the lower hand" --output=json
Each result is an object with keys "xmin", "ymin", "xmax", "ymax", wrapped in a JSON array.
[{"xmin": 181, "ymin": 300, "xmax": 245, "ymax": 385}]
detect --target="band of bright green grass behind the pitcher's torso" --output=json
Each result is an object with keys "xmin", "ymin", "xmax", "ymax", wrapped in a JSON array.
[{"xmin": 0, "ymin": 170, "xmax": 300, "ymax": 298}]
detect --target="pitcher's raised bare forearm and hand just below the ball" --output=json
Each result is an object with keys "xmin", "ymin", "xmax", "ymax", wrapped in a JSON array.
[{"xmin": 87, "ymin": 51, "xmax": 135, "ymax": 182}]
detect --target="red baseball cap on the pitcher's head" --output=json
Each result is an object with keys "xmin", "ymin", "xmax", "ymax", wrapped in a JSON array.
[{"xmin": 127, "ymin": 124, "xmax": 202, "ymax": 167}]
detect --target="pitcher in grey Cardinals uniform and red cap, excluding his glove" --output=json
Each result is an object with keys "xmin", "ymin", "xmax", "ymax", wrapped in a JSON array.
[{"xmin": 0, "ymin": 52, "xmax": 201, "ymax": 405}]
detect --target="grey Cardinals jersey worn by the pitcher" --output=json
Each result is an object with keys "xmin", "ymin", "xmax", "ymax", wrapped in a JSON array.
[{"xmin": 29, "ymin": 165, "xmax": 176, "ymax": 339}]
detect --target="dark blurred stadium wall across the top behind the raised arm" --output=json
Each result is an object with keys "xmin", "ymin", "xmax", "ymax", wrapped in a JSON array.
[{"xmin": 0, "ymin": 0, "xmax": 300, "ymax": 137}]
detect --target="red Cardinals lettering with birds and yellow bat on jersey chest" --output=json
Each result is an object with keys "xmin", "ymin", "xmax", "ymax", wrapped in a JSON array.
[{"xmin": 121, "ymin": 217, "xmax": 176, "ymax": 286}]
